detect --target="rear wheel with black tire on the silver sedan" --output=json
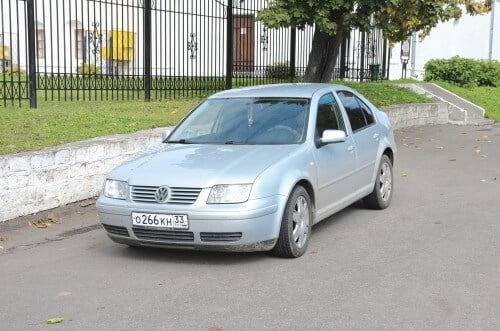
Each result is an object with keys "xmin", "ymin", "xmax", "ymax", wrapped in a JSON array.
[{"xmin": 363, "ymin": 155, "xmax": 394, "ymax": 209}]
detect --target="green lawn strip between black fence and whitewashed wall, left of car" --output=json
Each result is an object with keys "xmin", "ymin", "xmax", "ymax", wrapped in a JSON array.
[{"xmin": 0, "ymin": 98, "xmax": 200, "ymax": 155}]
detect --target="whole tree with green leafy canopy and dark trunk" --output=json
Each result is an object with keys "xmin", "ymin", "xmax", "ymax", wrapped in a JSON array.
[{"xmin": 257, "ymin": 0, "xmax": 492, "ymax": 82}]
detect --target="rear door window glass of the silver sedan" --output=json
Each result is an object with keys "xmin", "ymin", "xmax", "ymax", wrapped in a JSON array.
[{"xmin": 338, "ymin": 91, "xmax": 375, "ymax": 131}]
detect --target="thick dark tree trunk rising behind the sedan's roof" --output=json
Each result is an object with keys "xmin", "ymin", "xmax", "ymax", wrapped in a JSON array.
[{"xmin": 304, "ymin": 25, "xmax": 344, "ymax": 83}]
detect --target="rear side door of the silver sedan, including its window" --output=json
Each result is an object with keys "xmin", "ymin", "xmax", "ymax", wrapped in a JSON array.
[{"xmin": 337, "ymin": 91, "xmax": 380, "ymax": 189}]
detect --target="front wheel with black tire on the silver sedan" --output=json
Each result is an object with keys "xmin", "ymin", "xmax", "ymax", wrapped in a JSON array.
[{"xmin": 272, "ymin": 186, "xmax": 312, "ymax": 258}]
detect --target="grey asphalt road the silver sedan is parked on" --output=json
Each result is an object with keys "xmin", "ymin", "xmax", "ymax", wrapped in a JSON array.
[{"xmin": 0, "ymin": 124, "xmax": 500, "ymax": 331}]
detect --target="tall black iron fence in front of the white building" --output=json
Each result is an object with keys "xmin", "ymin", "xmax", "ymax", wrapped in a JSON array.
[{"xmin": 0, "ymin": 0, "xmax": 388, "ymax": 107}]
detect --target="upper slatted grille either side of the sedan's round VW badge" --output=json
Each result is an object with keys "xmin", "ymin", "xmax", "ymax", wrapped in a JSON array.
[{"xmin": 130, "ymin": 186, "xmax": 201, "ymax": 205}]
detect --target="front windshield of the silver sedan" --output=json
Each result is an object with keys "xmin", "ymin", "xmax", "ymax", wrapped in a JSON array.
[{"xmin": 167, "ymin": 98, "xmax": 309, "ymax": 144}]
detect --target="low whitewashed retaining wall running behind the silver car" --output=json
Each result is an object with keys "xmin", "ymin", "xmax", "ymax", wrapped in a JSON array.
[{"xmin": 0, "ymin": 104, "xmax": 448, "ymax": 222}]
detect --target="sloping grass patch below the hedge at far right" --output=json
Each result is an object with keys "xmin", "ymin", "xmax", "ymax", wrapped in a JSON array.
[{"xmin": 434, "ymin": 82, "xmax": 500, "ymax": 122}]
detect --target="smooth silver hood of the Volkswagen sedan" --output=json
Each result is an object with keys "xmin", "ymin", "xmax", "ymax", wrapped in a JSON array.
[{"xmin": 108, "ymin": 144, "xmax": 299, "ymax": 188}]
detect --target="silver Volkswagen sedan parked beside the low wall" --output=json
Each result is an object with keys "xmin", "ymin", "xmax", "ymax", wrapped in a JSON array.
[{"xmin": 97, "ymin": 84, "xmax": 396, "ymax": 257}]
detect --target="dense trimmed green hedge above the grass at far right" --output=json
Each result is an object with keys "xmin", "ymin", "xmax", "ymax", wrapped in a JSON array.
[{"xmin": 424, "ymin": 56, "xmax": 500, "ymax": 87}]
